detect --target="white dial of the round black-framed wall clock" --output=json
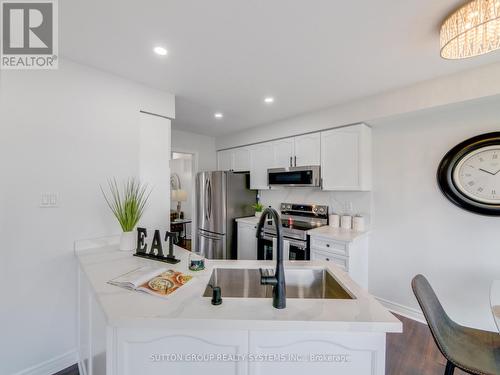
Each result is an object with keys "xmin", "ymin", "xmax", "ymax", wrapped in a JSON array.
[{"xmin": 452, "ymin": 145, "xmax": 500, "ymax": 204}]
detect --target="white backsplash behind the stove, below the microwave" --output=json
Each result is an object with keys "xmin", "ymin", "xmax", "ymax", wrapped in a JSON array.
[{"xmin": 259, "ymin": 188, "xmax": 372, "ymax": 224}]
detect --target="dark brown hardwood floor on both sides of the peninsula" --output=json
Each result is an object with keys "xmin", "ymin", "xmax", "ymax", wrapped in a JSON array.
[{"xmin": 55, "ymin": 315, "xmax": 466, "ymax": 375}]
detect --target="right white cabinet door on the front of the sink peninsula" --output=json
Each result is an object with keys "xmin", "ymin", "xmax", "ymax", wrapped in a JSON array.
[{"xmin": 248, "ymin": 331, "xmax": 385, "ymax": 375}]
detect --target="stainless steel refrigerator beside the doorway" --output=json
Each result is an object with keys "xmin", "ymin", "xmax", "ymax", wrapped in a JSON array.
[{"xmin": 196, "ymin": 171, "xmax": 257, "ymax": 259}]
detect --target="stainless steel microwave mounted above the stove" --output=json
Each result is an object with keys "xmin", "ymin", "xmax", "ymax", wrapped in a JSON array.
[{"xmin": 267, "ymin": 165, "xmax": 321, "ymax": 187}]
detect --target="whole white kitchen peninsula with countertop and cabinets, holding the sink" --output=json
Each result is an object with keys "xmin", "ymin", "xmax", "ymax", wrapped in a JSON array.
[{"xmin": 75, "ymin": 238, "xmax": 402, "ymax": 375}]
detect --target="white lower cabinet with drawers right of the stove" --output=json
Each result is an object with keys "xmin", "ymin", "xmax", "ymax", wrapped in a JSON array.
[{"xmin": 310, "ymin": 234, "xmax": 369, "ymax": 289}]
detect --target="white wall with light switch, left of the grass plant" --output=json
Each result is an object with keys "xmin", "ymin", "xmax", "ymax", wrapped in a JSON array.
[{"xmin": 0, "ymin": 61, "xmax": 175, "ymax": 374}]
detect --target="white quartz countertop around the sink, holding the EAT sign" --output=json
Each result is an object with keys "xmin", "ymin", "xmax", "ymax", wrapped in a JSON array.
[{"xmin": 75, "ymin": 245, "xmax": 402, "ymax": 332}]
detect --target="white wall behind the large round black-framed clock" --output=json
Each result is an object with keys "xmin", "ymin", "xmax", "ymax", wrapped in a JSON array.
[{"xmin": 370, "ymin": 97, "xmax": 500, "ymax": 330}]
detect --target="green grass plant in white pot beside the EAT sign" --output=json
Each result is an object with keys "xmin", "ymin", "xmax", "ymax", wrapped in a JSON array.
[{"xmin": 101, "ymin": 178, "xmax": 151, "ymax": 251}]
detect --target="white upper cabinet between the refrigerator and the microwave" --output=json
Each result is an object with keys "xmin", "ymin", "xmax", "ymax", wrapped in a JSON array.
[{"xmin": 250, "ymin": 142, "xmax": 274, "ymax": 189}]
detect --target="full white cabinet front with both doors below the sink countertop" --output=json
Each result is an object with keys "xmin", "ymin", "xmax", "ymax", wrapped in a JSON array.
[{"xmin": 86, "ymin": 327, "xmax": 385, "ymax": 375}]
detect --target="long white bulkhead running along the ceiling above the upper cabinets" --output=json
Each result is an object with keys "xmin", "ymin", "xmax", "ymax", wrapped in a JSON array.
[{"xmin": 217, "ymin": 63, "xmax": 500, "ymax": 150}]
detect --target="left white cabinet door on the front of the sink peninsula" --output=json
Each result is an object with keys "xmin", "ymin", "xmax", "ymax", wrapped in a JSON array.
[{"xmin": 117, "ymin": 328, "xmax": 248, "ymax": 375}]
